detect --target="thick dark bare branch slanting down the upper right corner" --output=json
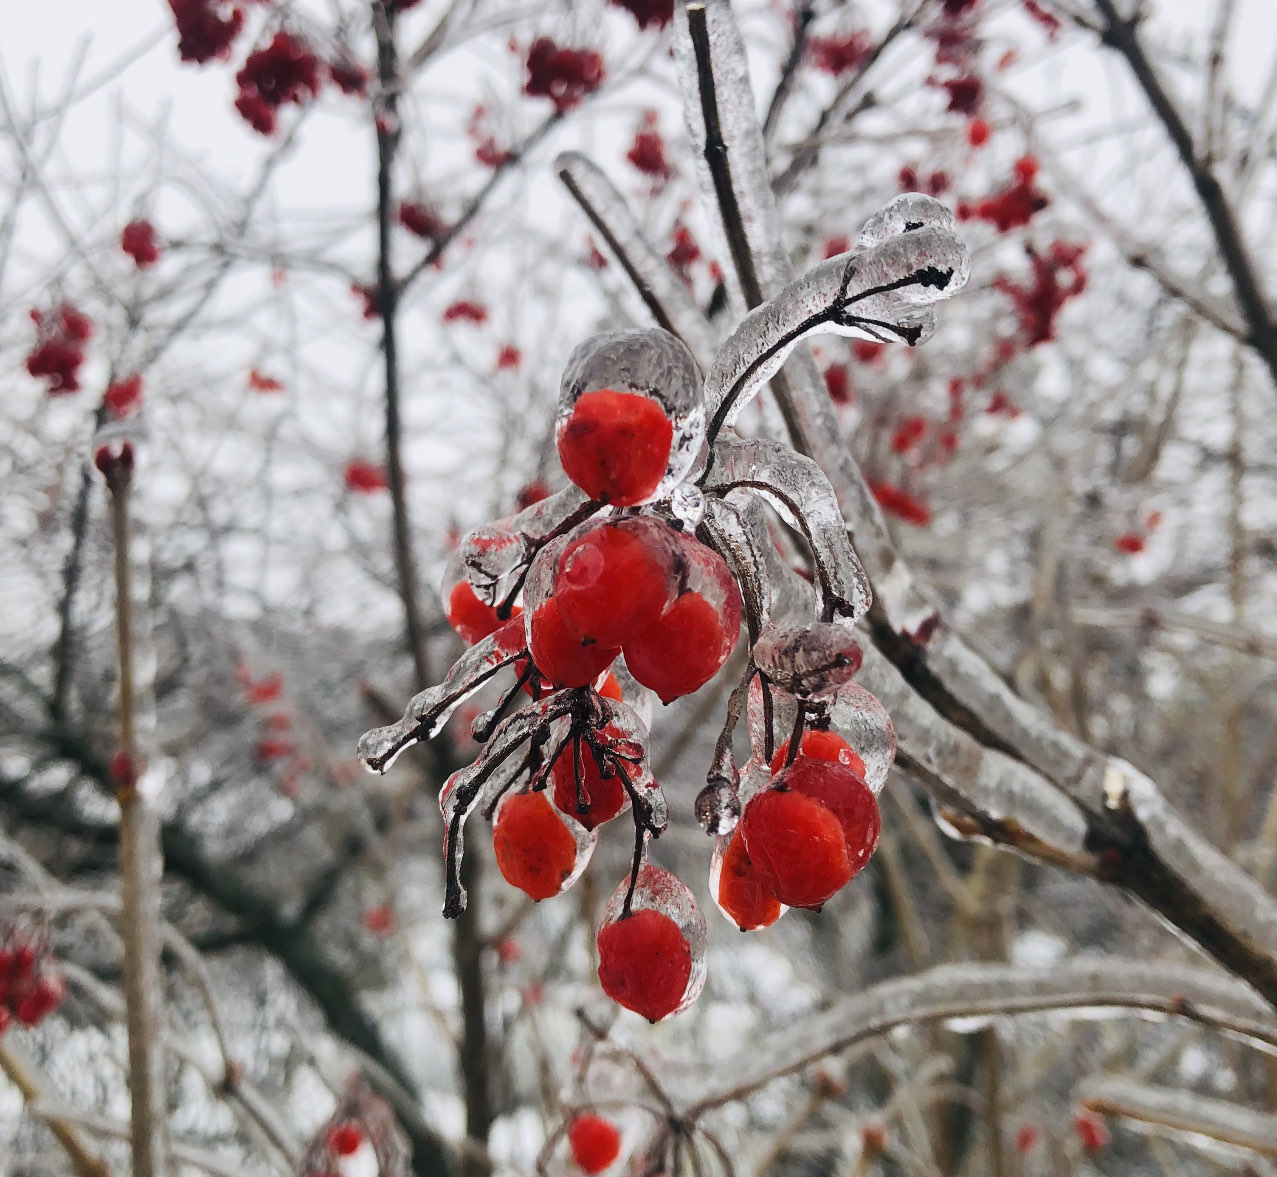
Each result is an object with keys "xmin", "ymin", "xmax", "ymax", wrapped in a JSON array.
[{"xmin": 1096, "ymin": 0, "xmax": 1277, "ymax": 395}]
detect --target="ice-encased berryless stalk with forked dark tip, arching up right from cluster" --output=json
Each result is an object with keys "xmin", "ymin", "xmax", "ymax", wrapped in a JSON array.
[{"xmin": 705, "ymin": 222, "xmax": 971, "ymax": 438}]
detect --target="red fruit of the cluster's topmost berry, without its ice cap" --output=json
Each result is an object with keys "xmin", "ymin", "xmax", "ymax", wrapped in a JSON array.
[{"xmin": 558, "ymin": 388, "xmax": 674, "ymax": 507}]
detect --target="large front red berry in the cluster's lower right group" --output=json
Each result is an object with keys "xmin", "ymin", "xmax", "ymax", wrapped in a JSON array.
[{"xmin": 739, "ymin": 789, "xmax": 854, "ymax": 908}]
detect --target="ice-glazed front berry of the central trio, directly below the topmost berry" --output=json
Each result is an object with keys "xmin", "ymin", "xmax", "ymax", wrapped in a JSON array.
[{"xmin": 553, "ymin": 516, "xmax": 683, "ymax": 643}]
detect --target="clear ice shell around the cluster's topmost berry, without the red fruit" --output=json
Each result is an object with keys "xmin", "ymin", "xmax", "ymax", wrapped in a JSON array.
[{"xmin": 555, "ymin": 327, "xmax": 705, "ymax": 506}]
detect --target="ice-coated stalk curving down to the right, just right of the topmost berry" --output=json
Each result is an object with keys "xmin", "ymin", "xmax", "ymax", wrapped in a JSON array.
[{"xmin": 705, "ymin": 437, "xmax": 872, "ymax": 622}]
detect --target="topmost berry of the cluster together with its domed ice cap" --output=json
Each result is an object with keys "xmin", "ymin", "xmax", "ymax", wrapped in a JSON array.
[{"xmin": 555, "ymin": 328, "xmax": 705, "ymax": 507}]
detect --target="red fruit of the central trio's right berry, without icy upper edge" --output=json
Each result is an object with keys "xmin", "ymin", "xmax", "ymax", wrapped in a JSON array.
[{"xmin": 624, "ymin": 592, "xmax": 741, "ymax": 703}]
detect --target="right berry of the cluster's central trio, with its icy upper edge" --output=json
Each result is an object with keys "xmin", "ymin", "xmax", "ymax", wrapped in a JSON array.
[{"xmin": 622, "ymin": 536, "xmax": 741, "ymax": 703}]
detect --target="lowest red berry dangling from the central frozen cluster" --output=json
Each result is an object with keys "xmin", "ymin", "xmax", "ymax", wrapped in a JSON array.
[{"xmin": 595, "ymin": 908, "xmax": 692, "ymax": 1021}]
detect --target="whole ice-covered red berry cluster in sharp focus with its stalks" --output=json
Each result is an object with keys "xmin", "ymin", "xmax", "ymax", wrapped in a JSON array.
[{"xmin": 360, "ymin": 194, "xmax": 967, "ymax": 1021}]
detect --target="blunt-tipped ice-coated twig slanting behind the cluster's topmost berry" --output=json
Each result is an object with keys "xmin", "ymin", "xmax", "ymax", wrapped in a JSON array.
[{"xmin": 554, "ymin": 151, "xmax": 718, "ymax": 369}]
